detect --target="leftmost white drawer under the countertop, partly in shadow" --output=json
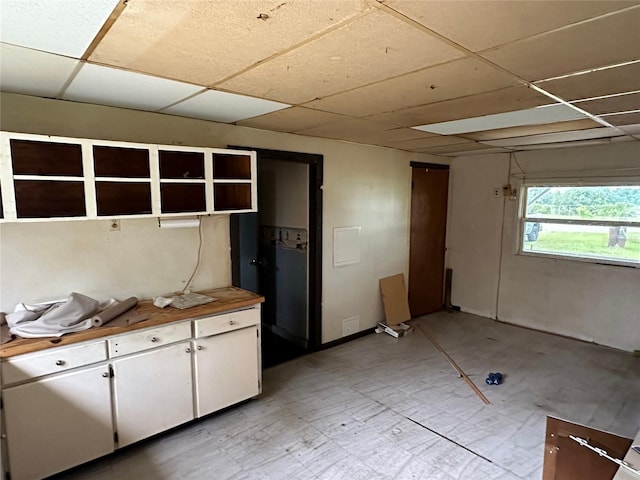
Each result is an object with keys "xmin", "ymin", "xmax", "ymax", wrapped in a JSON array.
[{"xmin": 2, "ymin": 340, "xmax": 107, "ymax": 385}]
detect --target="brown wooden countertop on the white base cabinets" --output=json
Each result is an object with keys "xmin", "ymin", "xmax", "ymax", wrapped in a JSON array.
[{"xmin": 0, "ymin": 287, "xmax": 264, "ymax": 358}]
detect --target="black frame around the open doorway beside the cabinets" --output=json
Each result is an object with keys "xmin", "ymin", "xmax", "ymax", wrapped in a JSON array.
[{"xmin": 228, "ymin": 145, "xmax": 324, "ymax": 352}]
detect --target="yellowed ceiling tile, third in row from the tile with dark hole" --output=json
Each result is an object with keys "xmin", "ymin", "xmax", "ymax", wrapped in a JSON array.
[{"xmin": 307, "ymin": 58, "xmax": 517, "ymax": 117}]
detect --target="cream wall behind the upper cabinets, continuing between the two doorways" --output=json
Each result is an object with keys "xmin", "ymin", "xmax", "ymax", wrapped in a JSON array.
[{"xmin": 0, "ymin": 94, "xmax": 441, "ymax": 342}]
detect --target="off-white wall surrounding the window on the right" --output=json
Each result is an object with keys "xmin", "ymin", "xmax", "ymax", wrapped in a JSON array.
[{"xmin": 448, "ymin": 142, "xmax": 640, "ymax": 350}]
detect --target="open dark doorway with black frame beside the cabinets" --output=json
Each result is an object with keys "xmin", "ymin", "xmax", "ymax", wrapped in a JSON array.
[{"xmin": 230, "ymin": 147, "xmax": 322, "ymax": 368}]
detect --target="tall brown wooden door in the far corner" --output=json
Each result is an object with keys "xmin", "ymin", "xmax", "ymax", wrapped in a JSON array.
[{"xmin": 409, "ymin": 164, "xmax": 449, "ymax": 317}]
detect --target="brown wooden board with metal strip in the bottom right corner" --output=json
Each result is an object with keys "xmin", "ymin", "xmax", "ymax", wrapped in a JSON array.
[{"xmin": 542, "ymin": 417, "xmax": 631, "ymax": 480}]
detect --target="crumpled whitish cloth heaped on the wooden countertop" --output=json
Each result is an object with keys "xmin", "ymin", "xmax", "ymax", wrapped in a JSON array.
[{"xmin": 6, "ymin": 292, "xmax": 101, "ymax": 338}]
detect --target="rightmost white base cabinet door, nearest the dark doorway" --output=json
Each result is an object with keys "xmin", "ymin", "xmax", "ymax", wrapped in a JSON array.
[{"xmin": 195, "ymin": 327, "xmax": 261, "ymax": 417}]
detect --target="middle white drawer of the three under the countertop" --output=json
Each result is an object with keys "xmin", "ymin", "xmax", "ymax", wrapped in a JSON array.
[{"xmin": 109, "ymin": 322, "xmax": 191, "ymax": 358}]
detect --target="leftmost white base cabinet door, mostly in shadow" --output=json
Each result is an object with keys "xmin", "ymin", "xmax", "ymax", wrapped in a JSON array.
[{"xmin": 2, "ymin": 366, "xmax": 114, "ymax": 480}]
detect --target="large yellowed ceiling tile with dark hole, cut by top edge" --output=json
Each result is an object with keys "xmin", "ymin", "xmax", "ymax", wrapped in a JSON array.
[{"xmin": 90, "ymin": 0, "xmax": 369, "ymax": 86}]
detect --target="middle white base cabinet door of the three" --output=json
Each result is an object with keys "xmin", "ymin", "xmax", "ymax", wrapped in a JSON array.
[{"xmin": 113, "ymin": 342, "xmax": 193, "ymax": 447}]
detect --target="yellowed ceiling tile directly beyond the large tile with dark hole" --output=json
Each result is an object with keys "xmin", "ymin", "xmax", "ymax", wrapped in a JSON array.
[{"xmin": 220, "ymin": 9, "xmax": 462, "ymax": 104}]
